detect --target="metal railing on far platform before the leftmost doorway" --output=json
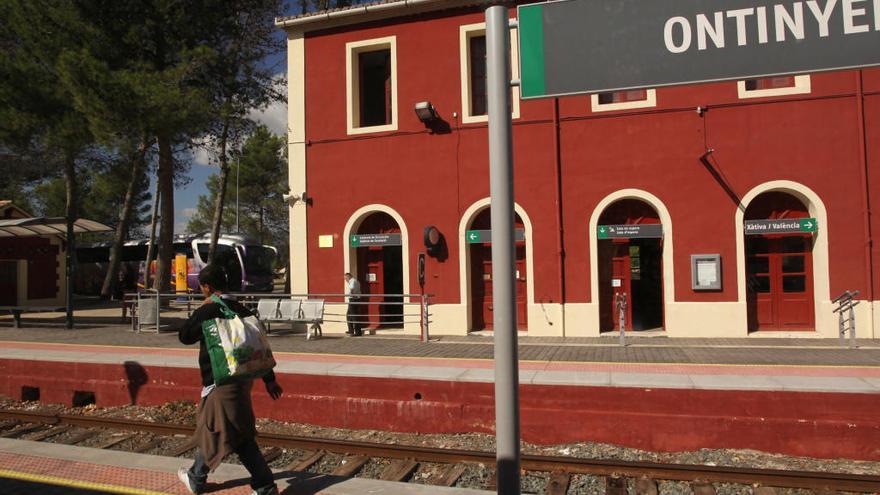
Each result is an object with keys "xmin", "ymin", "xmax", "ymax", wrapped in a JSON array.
[{"xmin": 122, "ymin": 289, "xmax": 434, "ymax": 341}]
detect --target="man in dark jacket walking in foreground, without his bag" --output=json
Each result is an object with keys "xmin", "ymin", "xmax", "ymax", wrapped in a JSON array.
[{"xmin": 177, "ymin": 264, "xmax": 283, "ymax": 495}]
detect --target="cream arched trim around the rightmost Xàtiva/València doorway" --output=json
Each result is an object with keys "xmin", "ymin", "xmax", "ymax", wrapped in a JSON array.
[{"xmin": 734, "ymin": 180, "xmax": 836, "ymax": 337}]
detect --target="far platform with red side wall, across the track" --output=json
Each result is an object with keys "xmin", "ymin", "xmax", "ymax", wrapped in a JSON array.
[{"xmin": 0, "ymin": 314, "xmax": 880, "ymax": 460}]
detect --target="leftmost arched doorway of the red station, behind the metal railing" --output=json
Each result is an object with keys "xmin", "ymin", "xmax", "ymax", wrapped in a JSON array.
[{"xmin": 350, "ymin": 212, "xmax": 403, "ymax": 328}]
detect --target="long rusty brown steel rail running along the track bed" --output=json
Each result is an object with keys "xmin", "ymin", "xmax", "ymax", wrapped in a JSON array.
[{"xmin": 0, "ymin": 409, "xmax": 880, "ymax": 493}]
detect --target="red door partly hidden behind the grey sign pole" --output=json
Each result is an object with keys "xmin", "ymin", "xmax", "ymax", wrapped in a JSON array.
[{"xmin": 470, "ymin": 244, "xmax": 528, "ymax": 330}]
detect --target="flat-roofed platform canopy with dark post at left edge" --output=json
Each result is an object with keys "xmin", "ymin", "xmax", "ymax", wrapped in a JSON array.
[{"xmin": 0, "ymin": 217, "xmax": 113, "ymax": 328}]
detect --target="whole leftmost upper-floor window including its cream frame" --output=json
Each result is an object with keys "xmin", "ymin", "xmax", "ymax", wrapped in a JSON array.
[{"xmin": 346, "ymin": 36, "xmax": 397, "ymax": 134}]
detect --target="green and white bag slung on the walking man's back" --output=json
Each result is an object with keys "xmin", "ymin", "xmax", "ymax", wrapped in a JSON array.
[{"xmin": 202, "ymin": 295, "xmax": 275, "ymax": 385}]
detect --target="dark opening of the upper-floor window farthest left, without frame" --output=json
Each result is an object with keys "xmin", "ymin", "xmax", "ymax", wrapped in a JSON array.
[{"xmin": 358, "ymin": 49, "xmax": 391, "ymax": 127}]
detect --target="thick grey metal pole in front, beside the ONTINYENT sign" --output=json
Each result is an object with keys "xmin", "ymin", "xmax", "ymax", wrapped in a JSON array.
[{"xmin": 486, "ymin": 5, "xmax": 520, "ymax": 495}]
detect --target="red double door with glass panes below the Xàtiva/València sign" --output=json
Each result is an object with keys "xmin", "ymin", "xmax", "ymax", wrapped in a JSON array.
[{"xmin": 746, "ymin": 235, "xmax": 815, "ymax": 330}]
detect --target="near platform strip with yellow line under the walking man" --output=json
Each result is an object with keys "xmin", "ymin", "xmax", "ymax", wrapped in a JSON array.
[{"xmin": 0, "ymin": 438, "xmax": 490, "ymax": 495}]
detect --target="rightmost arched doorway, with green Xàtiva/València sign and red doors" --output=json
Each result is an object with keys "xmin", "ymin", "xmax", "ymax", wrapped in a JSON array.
[{"xmin": 744, "ymin": 191, "xmax": 816, "ymax": 332}]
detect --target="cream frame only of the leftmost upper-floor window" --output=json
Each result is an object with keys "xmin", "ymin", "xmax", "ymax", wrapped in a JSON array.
[{"xmin": 345, "ymin": 36, "xmax": 397, "ymax": 135}]
